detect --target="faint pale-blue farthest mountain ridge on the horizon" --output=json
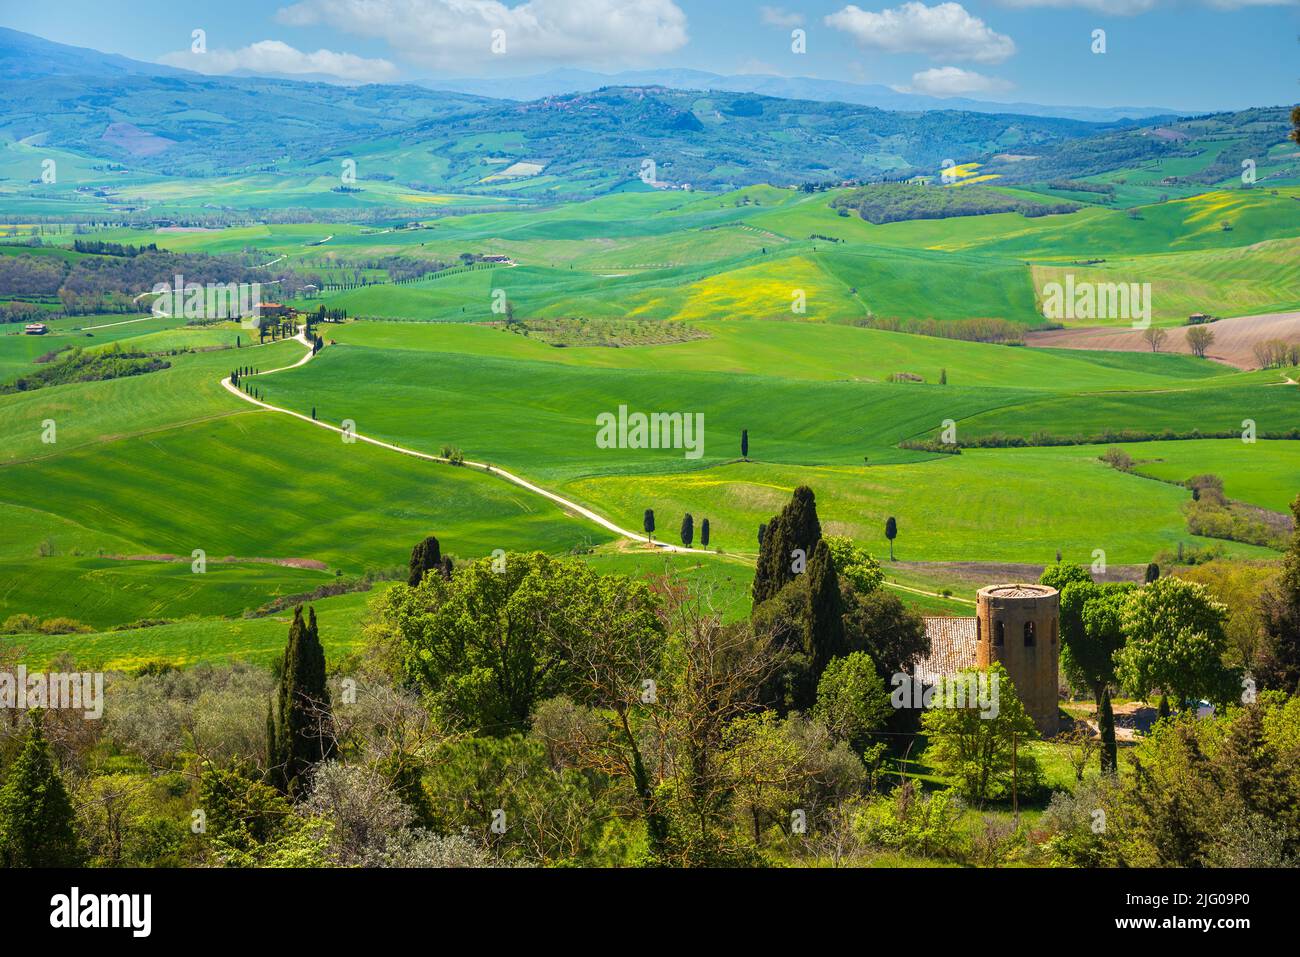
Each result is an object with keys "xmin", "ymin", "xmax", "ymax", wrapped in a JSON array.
[{"xmin": 420, "ymin": 69, "xmax": 1186, "ymax": 124}]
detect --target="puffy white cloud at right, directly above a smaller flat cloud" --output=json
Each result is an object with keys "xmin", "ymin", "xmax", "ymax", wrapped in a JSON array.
[{"xmin": 826, "ymin": 3, "xmax": 1015, "ymax": 64}]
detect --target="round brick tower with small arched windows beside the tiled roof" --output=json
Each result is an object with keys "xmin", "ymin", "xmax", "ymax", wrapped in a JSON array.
[{"xmin": 975, "ymin": 585, "xmax": 1061, "ymax": 737}]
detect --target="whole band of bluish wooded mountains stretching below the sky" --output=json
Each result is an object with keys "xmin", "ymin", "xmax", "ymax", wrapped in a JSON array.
[{"xmin": 0, "ymin": 29, "xmax": 1286, "ymax": 202}]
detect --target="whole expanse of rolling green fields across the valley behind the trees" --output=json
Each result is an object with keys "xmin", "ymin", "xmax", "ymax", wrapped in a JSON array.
[{"xmin": 0, "ymin": 149, "xmax": 1300, "ymax": 664}]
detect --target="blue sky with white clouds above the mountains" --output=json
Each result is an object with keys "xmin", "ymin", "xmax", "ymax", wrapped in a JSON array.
[{"xmin": 0, "ymin": 0, "xmax": 1300, "ymax": 113}]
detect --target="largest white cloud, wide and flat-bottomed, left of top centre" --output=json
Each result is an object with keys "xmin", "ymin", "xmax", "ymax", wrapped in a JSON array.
[{"xmin": 277, "ymin": 0, "xmax": 688, "ymax": 70}]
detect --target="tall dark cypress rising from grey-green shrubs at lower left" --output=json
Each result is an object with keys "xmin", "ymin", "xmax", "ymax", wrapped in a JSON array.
[{"xmin": 267, "ymin": 605, "xmax": 334, "ymax": 794}]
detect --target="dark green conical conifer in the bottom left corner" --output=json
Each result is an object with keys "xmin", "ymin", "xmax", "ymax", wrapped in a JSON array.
[{"xmin": 0, "ymin": 709, "xmax": 81, "ymax": 867}]
